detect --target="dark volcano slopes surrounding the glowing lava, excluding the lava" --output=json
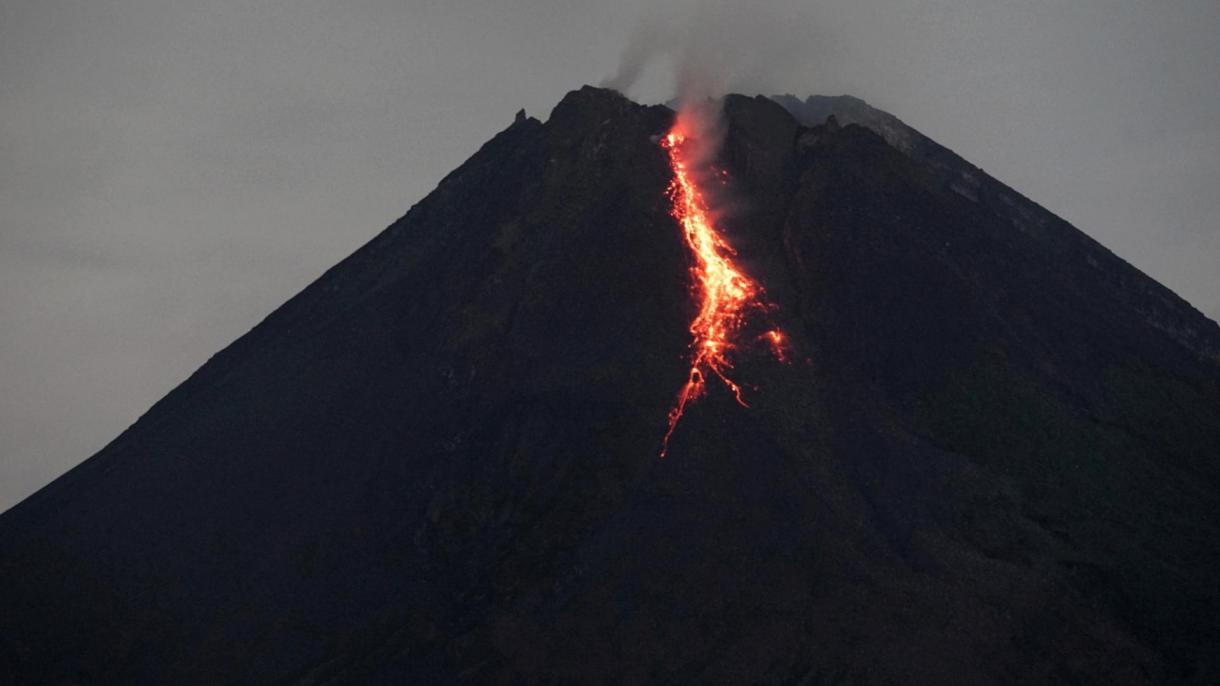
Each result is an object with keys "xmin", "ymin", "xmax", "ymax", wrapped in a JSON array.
[{"xmin": 0, "ymin": 88, "xmax": 1220, "ymax": 685}]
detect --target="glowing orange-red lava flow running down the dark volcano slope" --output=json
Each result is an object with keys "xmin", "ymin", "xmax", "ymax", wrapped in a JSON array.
[{"xmin": 661, "ymin": 114, "xmax": 783, "ymax": 458}]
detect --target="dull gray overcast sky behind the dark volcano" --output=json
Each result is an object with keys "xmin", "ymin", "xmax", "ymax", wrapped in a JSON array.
[{"xmin": 0, "ymin": 0, "xmax": 1220, "ymax": 510}]
